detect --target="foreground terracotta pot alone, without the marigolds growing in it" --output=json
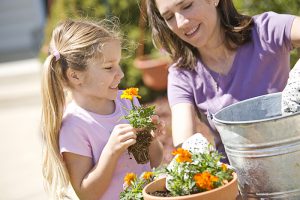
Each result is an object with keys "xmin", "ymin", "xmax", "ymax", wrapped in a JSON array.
[{"xmin": 143, "ymin": 173, "xmax": 238, "ymax": 200}]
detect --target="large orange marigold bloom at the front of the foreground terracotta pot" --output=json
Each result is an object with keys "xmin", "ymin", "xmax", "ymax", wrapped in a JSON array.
[{"xmin": 194, "ymin": 172, "xmax": 219, "ymax": 190}]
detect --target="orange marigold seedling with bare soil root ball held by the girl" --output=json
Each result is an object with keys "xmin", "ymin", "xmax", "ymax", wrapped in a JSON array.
[{"xmin": 121, "ymin": 88, "xmax": 156, "ymax": 164}]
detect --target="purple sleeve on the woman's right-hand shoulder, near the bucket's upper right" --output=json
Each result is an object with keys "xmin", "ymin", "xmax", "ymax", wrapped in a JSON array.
[{"xmin": 256, "ymin": 12, "xmax": 295, "ymax": 51}]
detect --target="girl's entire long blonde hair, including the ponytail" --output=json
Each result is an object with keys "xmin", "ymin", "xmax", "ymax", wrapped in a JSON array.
[{"xmin": 41, "ymin": 20, "xmax": 121, "ymax": 199}]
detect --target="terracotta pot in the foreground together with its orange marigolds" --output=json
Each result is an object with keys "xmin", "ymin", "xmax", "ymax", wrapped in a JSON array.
[{"xmin": 142, "ymin": 146, "xmax": 238, "ymax": 200}]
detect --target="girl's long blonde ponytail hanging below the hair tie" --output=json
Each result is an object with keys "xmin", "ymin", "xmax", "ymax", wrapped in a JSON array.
[{"xmin": 41, "ymin": 54, "xmax": 69, "ymax": 199}]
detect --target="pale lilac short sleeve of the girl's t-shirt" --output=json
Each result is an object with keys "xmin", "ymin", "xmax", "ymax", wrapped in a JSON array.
[{"xmin": 59, "ymin": 117, "xmax": 92, "ymax": 158}]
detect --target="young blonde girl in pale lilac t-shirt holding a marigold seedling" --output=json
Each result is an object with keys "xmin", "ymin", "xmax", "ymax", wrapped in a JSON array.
[{"xmin": 42, "ymin": 20, "xmax": 162, "ymax": 200}]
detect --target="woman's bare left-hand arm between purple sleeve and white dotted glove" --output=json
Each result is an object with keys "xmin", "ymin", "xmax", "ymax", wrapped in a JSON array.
[{"xmin": 171, "ymin": 103, "xmax": 196, "ymax": 147}]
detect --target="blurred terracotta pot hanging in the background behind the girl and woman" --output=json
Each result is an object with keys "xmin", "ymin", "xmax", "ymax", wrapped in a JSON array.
[{"xmin": 134, "ymin": 56, "xmax": 170, "ymax": 91}]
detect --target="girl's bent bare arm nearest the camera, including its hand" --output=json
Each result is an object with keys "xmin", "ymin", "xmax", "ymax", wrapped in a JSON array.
[{"xmin": 63, "ymin": 124, "xmax": 136, "ymax": 200}]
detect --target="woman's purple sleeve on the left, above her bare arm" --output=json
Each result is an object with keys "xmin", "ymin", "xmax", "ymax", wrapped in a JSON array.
[{"xmin": 167, "ymin": 66, "xmax": 194, "ymax": 107}]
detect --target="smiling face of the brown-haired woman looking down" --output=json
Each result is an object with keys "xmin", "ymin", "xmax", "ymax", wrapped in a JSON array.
[{"xmin": 155, "ymin": 0, "xmax": 220, "ymax": 48}]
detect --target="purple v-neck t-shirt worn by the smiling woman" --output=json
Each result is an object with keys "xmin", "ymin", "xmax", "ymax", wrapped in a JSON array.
[{"xmin": 168, "ymin": 12, "xmax": 295, "ymax": 156}]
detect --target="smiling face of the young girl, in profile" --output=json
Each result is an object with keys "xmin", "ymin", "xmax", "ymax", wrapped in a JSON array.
[{"xmin": 79, "ymin": 40, "xmax": 124, "ymax": 105}]
